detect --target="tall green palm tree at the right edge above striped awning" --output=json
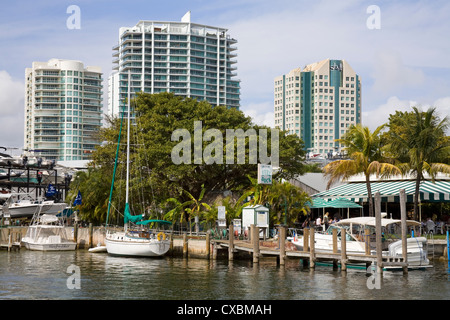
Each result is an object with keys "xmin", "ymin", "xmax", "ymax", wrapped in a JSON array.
[{"xmin": 389, "ymin": 107, "xmax": 450, "ymax": 220}]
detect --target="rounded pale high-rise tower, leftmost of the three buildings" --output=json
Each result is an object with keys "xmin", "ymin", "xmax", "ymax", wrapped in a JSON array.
[{"xmin": 24, "ymin": 59, "xmax": 103, "ymax": 161}]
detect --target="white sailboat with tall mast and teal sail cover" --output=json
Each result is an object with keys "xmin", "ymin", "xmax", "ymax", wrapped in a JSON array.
[{"xmin": 105, "ymin": 73, "xmax": 172, "ymax": 257}]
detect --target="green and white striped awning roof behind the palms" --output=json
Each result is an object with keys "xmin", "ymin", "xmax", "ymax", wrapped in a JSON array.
[{"xmin": 312, "ymin": 180, "xmax": 450, "ymax": 202}]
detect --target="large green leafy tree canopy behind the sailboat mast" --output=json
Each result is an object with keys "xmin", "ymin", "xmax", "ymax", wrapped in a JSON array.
[{"xmin": 73, "ymin": 93, "xmax": 307, "ymax": 228}]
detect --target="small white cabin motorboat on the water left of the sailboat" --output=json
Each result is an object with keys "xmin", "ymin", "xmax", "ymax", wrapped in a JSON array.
[{"xmin": 22, "ymin": 214, "xmax": 77, "ymax": 251}]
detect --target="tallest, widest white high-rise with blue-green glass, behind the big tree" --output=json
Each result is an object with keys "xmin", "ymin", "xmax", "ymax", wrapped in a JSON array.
[{"xmin": 108, "ymin": 12, "xmax": 240, "ymax": 115}]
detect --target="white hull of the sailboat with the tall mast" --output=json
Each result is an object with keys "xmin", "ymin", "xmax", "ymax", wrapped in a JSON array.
[{"xmin": 105, "ymin": 234, "xmax": 170, "ymax": 257}]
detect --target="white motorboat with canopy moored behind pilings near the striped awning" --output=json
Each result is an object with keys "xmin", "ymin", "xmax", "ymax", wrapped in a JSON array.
[{"xmin": 291, "ymin": 213, "xmax": 430, "ymax": 268}]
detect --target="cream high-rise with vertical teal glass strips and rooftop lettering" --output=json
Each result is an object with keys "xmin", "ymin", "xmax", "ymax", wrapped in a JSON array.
[{"xmin": 274, "ymin": 59, "xmax": 361, "ymax": 156}]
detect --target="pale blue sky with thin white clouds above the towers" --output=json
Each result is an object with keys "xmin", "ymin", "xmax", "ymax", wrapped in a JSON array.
[{"xmin": 0, "ymin": 0, "xmax": 450, "ymax": 153}]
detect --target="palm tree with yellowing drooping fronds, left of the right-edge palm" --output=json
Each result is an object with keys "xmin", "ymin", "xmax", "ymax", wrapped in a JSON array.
[{"xmin": 323, "ymin": 124, "xmax": 401, "ymax": 217}]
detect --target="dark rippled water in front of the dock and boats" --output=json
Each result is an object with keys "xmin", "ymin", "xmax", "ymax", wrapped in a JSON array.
[{"xmin": 0, "ymin": 250, "xmax": 450, "ymax": 300}]
